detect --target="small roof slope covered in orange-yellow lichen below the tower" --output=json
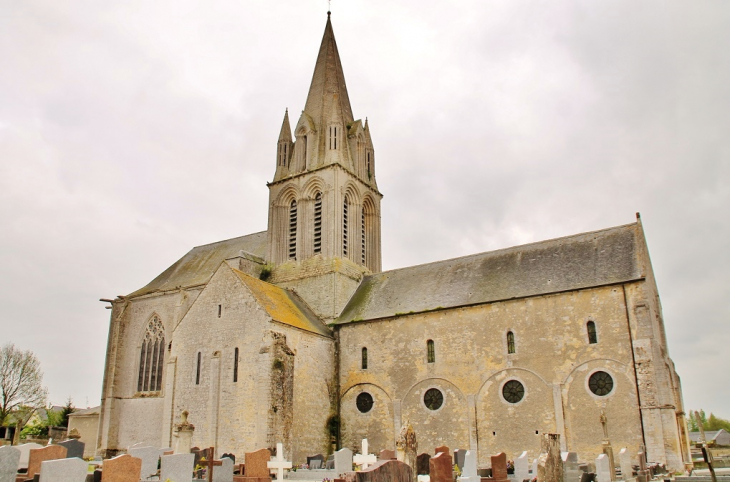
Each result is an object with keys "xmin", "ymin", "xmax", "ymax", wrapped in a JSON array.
[{"xmin": 231, "ymin": 268, "xmax": 332, "ymax": 337}]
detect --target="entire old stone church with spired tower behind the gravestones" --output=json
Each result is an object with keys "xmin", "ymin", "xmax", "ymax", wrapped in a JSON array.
[{"xmin": 98, "ymin": 15, "xmax": 691, "ymax": 470}]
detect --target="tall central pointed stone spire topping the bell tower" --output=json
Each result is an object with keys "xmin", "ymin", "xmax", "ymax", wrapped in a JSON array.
[{"xmin": 304, "ymin": 12, "xmax": 354, "ymax": 126}]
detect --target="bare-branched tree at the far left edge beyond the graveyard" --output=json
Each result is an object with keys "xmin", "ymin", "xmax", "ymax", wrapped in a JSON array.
[{"xmin": 0, "ymin": 343, "xmax": 48, "ymax": 428}]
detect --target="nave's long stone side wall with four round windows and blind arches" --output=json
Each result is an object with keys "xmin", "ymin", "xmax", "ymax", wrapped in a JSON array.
[{"xmin": 339, "ymin": 285, "xmax": 642, "ymax": 465}]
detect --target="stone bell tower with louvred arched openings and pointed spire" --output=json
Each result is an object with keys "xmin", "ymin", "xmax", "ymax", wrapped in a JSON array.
[{"xmin": 267, "ymin": 12, "xmax": 383, "ymax": 321}]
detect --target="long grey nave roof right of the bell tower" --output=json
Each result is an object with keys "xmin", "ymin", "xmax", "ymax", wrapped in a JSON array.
[{"xmin": 335, "ymin": 222, "xmax": 644, "ymax": 324}]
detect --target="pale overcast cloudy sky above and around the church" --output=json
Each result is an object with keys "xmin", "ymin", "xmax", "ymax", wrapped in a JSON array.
[{"xmin": 0, "ymin": 0, "xmax": 730, "ymax": 418}]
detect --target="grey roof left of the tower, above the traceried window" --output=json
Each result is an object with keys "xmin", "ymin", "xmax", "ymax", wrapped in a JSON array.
[{"xmin": 127, "ymin": 231, "xmax": 266, "ymax": 298}]
